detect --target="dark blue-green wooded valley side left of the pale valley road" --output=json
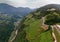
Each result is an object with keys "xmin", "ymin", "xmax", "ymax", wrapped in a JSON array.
[{"xmin": 0, "ymin": 14, "xmax": 21, "ymax": 42}]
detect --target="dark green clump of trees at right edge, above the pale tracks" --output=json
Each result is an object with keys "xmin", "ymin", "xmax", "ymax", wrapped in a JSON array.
[{"xmin": 45, "ymin": 13, "xmax": 60, "ymax": 25}]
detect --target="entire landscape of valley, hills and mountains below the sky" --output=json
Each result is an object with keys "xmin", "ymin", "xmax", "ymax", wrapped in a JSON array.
[{"xmin": 0, "ymin": 3, "xmax": 60, "ymax": 42}]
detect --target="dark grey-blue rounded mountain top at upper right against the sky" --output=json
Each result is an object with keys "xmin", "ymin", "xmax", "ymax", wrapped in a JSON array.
[{"xmin": 38, "ymin": 4, "xmax": 60, "ymax": 11}]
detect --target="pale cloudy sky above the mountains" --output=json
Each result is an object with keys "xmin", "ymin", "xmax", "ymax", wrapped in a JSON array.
[{"xmin": 0, "ymin": 0, "xmax": 60, "ymax": 9}]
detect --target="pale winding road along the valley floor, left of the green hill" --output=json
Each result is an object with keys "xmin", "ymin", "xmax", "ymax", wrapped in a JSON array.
[{"xmin": 8, "ymin": 20, "xmax": 20, "ymax": 42}]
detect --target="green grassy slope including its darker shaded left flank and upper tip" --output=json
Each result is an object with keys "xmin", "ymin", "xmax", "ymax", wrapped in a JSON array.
[{"xmin": 14, "ymin": 11, "xmax": 53, "ymax": 42}]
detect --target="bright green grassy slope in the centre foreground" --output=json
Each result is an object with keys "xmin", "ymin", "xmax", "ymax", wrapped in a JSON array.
[{"xmin": 25, "ymin": 15, "xmax": 52, "ymax": 42}]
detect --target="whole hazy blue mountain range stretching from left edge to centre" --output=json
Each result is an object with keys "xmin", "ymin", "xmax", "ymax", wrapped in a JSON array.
[{"xmin": 0, "ymin": 3, "xmax": 32, "ymax": 15}]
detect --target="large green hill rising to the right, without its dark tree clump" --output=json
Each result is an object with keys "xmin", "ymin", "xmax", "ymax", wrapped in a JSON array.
[{"xmin": 13, "ymin": 4, "xmax": 60, "ymax": 42}]
